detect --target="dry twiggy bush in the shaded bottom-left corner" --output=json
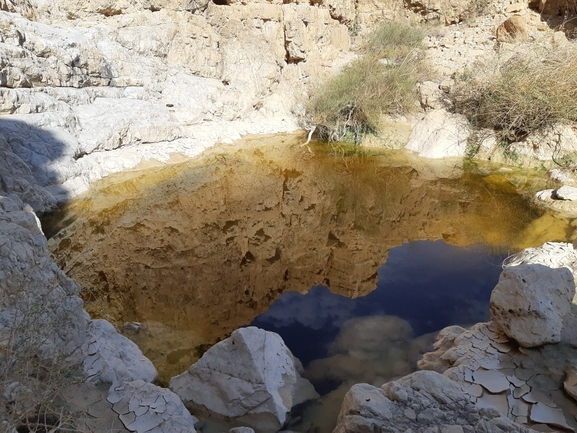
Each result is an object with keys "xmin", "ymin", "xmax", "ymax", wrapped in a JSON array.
[{"xmin": 0, "ymin": 286, "xmax": 83, "ymax": 433}]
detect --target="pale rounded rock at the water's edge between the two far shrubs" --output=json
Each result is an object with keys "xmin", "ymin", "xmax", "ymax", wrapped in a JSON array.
[{"xmin": 405, "ymin": 109, "xmax": 470, "ymax": 158}]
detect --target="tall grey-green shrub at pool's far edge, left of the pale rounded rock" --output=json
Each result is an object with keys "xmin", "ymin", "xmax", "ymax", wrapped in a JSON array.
[{"xmin": 307, "ymin": 22, "xmax": 423, "ymax": 143}]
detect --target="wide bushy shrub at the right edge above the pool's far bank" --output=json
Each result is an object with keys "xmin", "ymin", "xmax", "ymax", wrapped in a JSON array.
[{"xmin": 451, "ymin": 50, "xmax": 577, "ymax": 143}]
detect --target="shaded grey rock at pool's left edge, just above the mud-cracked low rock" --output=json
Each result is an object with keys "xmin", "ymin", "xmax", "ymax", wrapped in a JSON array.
[{"xmin": 84, "ymin": 319, "xmax": 157, "ymax": 386}]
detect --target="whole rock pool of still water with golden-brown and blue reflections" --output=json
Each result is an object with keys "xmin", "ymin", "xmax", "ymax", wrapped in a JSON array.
[{"xmin": 45, "ymin": 136, "xmax": 574, "ymax": 431}]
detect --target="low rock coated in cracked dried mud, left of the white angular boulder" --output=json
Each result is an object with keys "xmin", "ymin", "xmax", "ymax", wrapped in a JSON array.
[{"xmin": 108, "ymin": 380, "xmax": 197, "ymax": 433}]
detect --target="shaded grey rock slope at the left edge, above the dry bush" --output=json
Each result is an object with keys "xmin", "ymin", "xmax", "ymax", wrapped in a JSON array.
[{"xmin": 0, "ymin": 196, "xmax": 88, "ymax": 362}]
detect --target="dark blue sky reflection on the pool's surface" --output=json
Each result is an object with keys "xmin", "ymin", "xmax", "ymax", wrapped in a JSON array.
[{"xmin": 251, "ymin": 241, "xmax": 505, "ymax": 366}]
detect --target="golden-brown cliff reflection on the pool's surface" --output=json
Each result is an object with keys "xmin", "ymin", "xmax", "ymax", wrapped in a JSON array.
[{"xmin": 50, "ymin": 136, "xmax": 560, "ymax": 374}]
